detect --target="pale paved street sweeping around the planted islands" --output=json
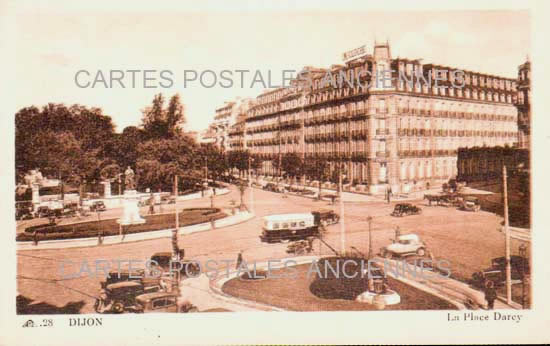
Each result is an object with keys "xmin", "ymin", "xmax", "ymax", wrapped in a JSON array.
[{"xmin": 17, "ymin": 187, "xmax": 519, "ymax": 313}]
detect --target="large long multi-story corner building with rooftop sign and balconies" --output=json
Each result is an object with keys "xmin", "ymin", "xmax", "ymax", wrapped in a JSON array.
[{"xmin": 243, "ymin": 43, "xmax": 518, "ymax": 193}]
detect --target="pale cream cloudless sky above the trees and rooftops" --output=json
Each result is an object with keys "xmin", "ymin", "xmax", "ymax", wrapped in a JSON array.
[{"xmin": 15, "ymin": 2, "xmax": 531, "ymax": 131}]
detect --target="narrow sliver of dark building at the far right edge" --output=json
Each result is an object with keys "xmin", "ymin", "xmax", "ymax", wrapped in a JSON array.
[{"xmin": 516, "ymin": 60, "xmax": 531, "ymax": 149}]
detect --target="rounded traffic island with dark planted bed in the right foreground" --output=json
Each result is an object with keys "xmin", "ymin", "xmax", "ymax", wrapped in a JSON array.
[{"xmin": 221, "ymin": 258, "xmax": 457, "ymax": 311}]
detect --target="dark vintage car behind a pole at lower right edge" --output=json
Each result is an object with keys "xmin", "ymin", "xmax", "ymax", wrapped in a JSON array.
[{"xmin": 472, "ymin": 255, "xmax": 530, "ymax": 287}]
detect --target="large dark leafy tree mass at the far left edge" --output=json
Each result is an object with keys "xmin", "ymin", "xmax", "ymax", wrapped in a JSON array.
[{"xmin": 15, "ymin": 103, "xmax": 114, "ymax": 187}]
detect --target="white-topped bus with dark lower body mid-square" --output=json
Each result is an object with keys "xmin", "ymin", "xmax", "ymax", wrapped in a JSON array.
[{"xmin": 260, "ymin": 213, "xmax": 319, "ymax": 243}]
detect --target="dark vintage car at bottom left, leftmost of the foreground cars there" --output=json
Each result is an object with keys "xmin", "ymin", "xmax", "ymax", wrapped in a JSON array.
[{"xmin": 94, "ymin": 281, "xmax": 162, "ymax": 314}]
